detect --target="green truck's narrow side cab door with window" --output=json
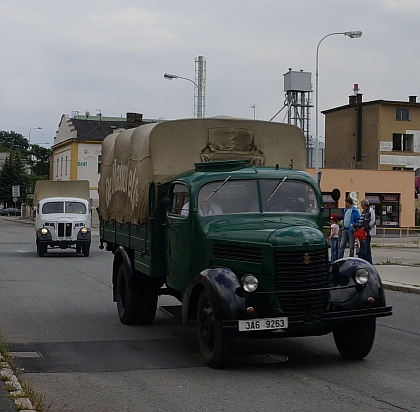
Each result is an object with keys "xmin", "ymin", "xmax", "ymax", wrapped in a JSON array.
[{"xmin": 166, "ymin": 183, "xmax": 192, "ymax": 291}]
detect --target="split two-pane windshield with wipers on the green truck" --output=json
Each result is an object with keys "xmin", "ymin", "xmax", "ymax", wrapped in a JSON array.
[{"xmin": 198, "ymin": 179, "xmax": 318, "ymax": 216}]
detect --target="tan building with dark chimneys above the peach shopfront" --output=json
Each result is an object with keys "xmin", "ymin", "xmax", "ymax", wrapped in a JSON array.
[{"xmin": 322, "ymin": 94, "xmax": 420, "ymax": 170}]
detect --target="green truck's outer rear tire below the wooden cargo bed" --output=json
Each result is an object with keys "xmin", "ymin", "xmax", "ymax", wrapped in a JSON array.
[{"xmin": 115, "ymin": 262, "xmax": 140, "ymax": 325}]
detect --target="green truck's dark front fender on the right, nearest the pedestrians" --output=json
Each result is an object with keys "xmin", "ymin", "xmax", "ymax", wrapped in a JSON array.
[{"xmin": 331, "ymin": 258, "xmax": 386, "ymax": 310}]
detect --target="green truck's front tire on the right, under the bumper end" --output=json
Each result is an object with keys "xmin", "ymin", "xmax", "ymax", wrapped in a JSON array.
[{"xmin": 333, "ymin": 318, "xmax": 376, "ymax": 360}]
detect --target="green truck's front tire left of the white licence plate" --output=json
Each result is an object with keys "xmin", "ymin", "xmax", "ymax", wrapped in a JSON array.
[{"xmin": 197, "ymin": 290, "xmax": 235, "ymax": 369}]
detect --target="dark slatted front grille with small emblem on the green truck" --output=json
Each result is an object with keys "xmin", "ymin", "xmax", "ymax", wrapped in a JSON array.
[{"xmin": 275, "ymin": 250, "xmax": 328, "ymax": 314}]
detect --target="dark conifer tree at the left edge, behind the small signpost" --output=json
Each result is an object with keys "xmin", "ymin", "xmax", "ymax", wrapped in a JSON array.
[{"xmin": 0, "ymin": 150, "xmax": 29, "ymax": 206}]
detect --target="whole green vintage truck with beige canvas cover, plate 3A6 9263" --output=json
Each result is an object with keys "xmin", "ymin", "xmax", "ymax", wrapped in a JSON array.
[{"xmin": 98, "ymin": 117, "xmax": 392, "ymax": 368}]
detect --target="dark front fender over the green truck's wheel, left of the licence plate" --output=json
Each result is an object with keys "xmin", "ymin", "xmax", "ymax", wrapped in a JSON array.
[{"xmin": 182, "ymin": 267, "xmax": 246, "ymax": 323}]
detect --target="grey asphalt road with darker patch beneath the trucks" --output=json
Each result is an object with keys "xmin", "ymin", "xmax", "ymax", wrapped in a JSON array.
[{"xmin": 0, "ymin": 218, "xmax": 420, "ymax": 412}]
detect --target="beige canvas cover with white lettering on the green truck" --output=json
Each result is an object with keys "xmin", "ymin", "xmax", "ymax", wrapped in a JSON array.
[{"xmin": 99, "ymin": 117, "xmax": 306, "ymax": 224}]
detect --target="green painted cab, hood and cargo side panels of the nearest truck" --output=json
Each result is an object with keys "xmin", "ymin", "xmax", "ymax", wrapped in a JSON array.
[{"xmin": 100, "ymin": 162, "xmax": 328, "ymax": 298}]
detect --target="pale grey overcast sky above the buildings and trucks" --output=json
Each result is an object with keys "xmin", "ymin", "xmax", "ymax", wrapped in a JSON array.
[{"xmin": 0, "ymin": 0, "xmax": 420, "ymax": 143}]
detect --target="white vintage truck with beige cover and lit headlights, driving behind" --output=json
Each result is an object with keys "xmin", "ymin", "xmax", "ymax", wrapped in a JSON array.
[{"xmin": 34, "ymin": 180, "xmax": 92, "ymax": 257}]
